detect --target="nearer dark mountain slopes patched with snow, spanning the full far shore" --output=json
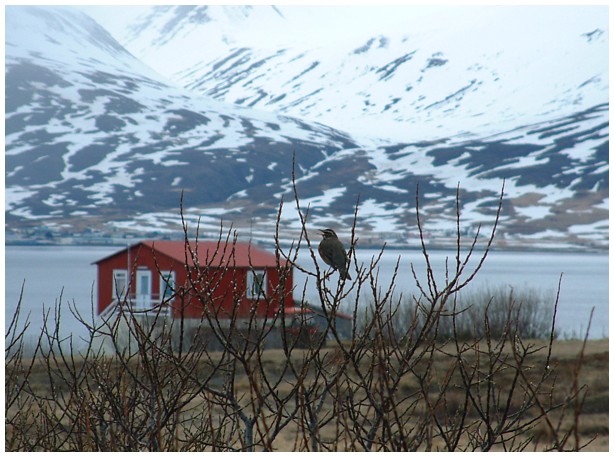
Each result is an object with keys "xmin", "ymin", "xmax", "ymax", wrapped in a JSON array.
[{"xmin": 5, "ymin": 7, "xmax": 609, "ymax": 248}]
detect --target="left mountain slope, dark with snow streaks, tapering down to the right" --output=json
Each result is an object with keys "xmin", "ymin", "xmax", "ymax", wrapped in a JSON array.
[{"xmin": 6, "ymin": 7, "xmax": 356, "ymax": 232}]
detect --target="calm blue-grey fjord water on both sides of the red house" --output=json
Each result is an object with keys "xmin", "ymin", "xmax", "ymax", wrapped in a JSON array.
[{"xmin": 5, "ymin": 246, "xmax": 609, "ymax": 350}]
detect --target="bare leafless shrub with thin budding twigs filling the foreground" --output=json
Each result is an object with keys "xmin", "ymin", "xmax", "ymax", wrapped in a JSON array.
[{"xmin": 5, "ymin": 176, "xmax": 600, "ymax": 451}]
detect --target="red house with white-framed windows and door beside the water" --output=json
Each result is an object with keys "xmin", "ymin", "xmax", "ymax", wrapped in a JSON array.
[{"xmin": 95, "ymin": 240, "xmax": 294, "ymax": 319}]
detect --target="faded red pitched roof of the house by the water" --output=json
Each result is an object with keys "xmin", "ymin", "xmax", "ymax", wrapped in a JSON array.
[{"xmin": 94, "ymin": 240, "xmax": 286, "ymax": 268}]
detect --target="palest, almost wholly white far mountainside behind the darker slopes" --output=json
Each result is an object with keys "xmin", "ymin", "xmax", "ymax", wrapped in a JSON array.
[{"xmin": 92, "ymin": 6, "xmax": 608, "ymax": 141}]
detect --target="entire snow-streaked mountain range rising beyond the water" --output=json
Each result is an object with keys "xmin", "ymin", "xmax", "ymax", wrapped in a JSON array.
[{"xmin": 5, "ymin": 7, "xmax": 609, "ymax": 247}]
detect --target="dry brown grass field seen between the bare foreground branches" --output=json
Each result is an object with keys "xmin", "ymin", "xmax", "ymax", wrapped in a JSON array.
[{"xmin": 5, "ymin": 340, "xmax": 609, "ymax": 451}]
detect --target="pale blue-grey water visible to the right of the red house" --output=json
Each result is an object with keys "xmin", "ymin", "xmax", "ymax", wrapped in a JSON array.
[{"xmin": 295, "ymin": 250, "xmax": 609, "ymax": 339}]
